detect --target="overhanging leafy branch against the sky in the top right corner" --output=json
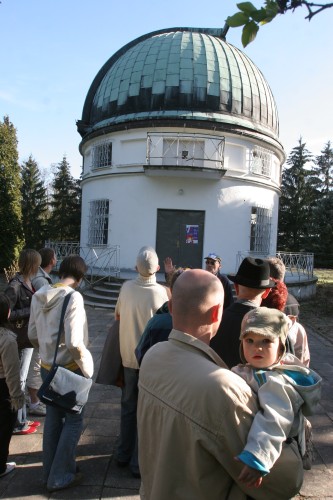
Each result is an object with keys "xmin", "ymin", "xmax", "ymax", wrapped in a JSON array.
[{"xmin": 226, "ymin": 0, "xmax": 333, "ymax": 47}]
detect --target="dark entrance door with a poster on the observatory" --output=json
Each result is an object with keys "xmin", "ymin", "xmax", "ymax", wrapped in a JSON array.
[{"xmin": 156, "ymin": 209, "xmax": 205, "ymax": 269}]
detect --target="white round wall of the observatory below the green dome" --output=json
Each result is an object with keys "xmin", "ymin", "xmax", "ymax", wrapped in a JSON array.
[{"xmin": 81, "ymin": 125, "xmax": 280, "ymax": 272}]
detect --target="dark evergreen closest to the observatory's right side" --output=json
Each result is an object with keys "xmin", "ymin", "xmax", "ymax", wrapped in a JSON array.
[{"xmin": 278, "ymin": 138, "xmax": 318, "ymax": 252}]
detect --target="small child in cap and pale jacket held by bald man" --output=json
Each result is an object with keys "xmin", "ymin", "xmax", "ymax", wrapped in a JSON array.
[{"xmin": 232, "ymin": 307, "xmax": 321, "ymax": 488}]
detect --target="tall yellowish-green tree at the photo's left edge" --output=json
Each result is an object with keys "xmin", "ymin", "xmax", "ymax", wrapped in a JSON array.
[{"xmin": 0, "ymin": 116, "xmax": 24, "ymax": 269}]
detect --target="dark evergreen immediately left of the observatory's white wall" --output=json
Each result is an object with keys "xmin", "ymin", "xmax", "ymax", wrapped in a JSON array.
[{"xmin": 49, "ymin": 156, "xmax": 81, "ymax": 241}]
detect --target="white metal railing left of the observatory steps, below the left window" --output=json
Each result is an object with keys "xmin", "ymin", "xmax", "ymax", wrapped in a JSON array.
[{"xmin": 45, "ymin": 241, "xmax": 120, "ymax": 289}]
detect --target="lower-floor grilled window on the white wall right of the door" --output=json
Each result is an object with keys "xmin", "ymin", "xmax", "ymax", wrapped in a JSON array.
[{"xmin": 250, "ymin": 207, "xmax": 272, "ymax": 254}]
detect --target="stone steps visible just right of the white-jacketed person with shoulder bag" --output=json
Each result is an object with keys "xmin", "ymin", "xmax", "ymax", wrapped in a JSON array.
[{"xmin": 82, "ymin": 278, "xmax": 125, "ymax": 311}]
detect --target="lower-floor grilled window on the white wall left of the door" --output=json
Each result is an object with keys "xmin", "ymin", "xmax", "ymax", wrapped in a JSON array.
[{"xmin": 88, "ymin": 200, "xmax": 109, "ymax": 247}]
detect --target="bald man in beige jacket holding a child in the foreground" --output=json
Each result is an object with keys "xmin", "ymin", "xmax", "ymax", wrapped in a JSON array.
[{"xmin": 138, "ymin": 269, "xmax": 303, "ymax": 500}]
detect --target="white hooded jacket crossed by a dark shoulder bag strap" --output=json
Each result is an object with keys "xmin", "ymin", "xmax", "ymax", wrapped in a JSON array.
[{"xmin": 28, "ymin": 284, "xmax": 94, "ymax": 377}]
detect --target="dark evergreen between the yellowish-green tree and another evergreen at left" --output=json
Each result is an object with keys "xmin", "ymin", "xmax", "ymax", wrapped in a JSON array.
[{"xmin": 21, "ymin": 155, "xmax": 48, "ymax": 249}]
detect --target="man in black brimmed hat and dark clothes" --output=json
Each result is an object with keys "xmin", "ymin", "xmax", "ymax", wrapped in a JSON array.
[{"xmin": 210, "ymin": 257, "xmax": 275, "ymax": 368}]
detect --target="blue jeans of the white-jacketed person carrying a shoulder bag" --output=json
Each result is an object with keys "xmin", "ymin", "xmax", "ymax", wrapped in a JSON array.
[{"xmin": 41, "ymin": 367, "xmax": 84, "ymax": 488}]
